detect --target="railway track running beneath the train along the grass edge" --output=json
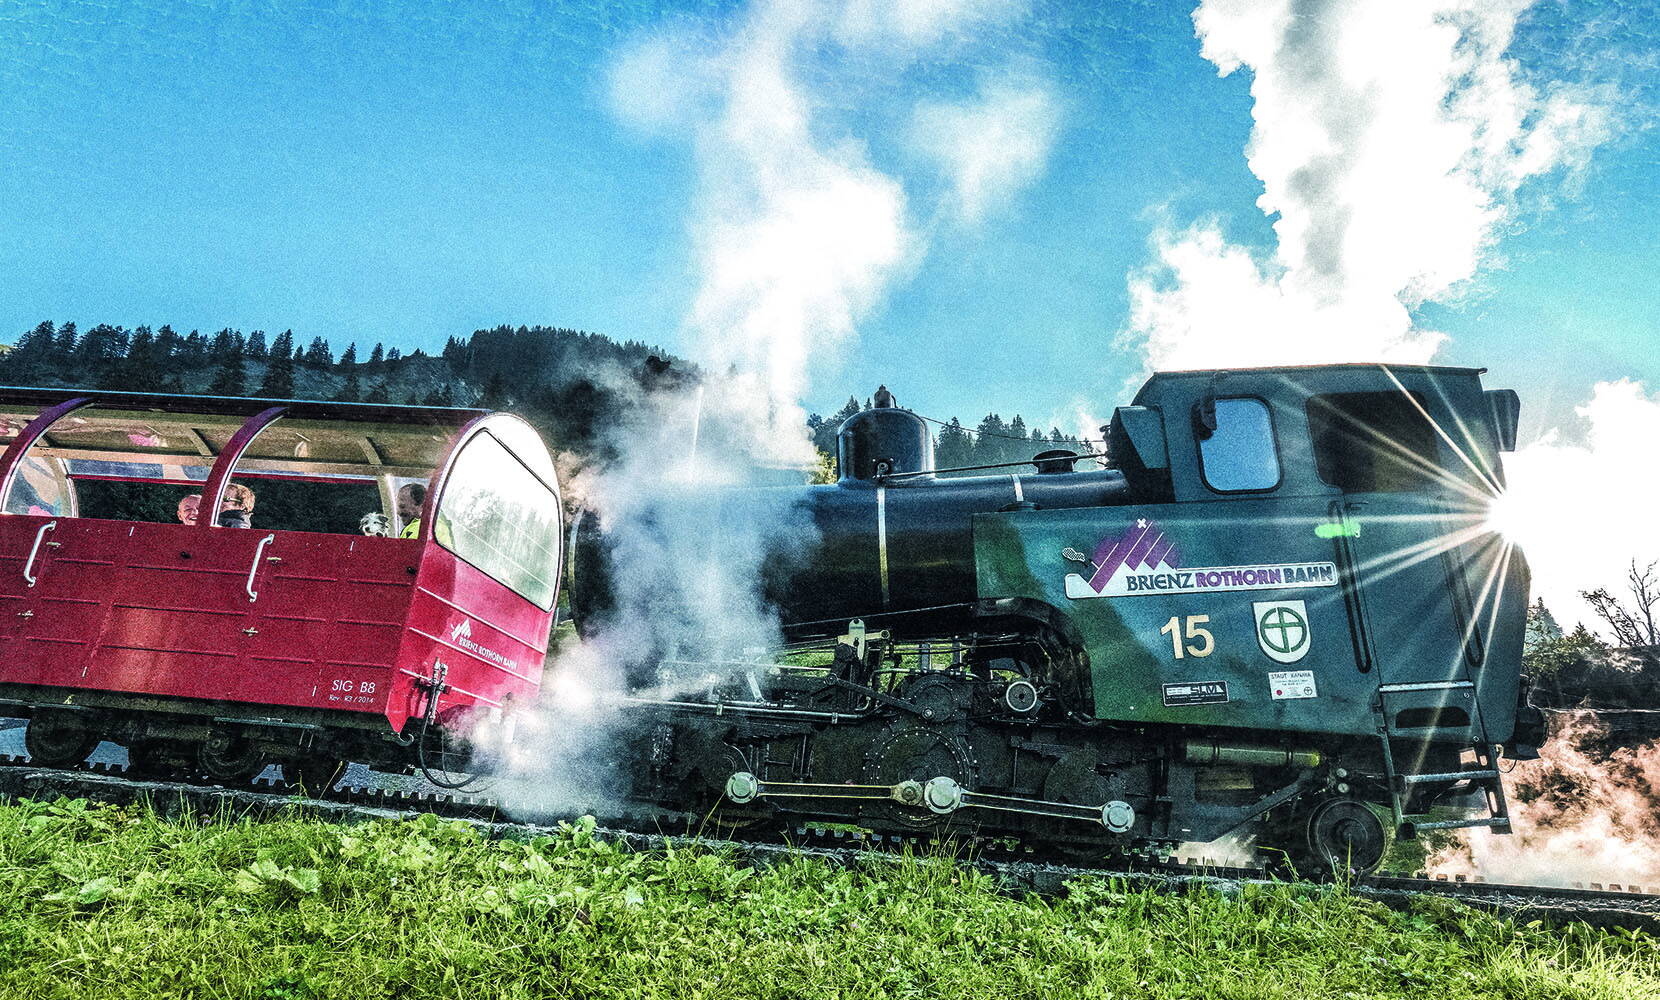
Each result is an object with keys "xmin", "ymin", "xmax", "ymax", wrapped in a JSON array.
[{"xmin": 0, "ymin": 754, "xmax": 1660, "ymax": 934}]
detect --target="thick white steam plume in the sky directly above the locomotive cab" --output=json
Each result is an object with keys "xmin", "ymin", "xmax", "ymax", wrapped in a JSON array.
[{"xmin": 1125, "ymin": 0, "xmax": 1610, "ymax": 369}]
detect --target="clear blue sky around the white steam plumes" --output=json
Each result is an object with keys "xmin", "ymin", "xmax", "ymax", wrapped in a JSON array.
[{"xmin": 0, "ymin": 0, "xmax": 1660, "ymax": 429}]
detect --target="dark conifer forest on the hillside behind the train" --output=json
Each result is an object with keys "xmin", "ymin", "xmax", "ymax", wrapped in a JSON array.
[{"xmin": 0, "ymin": 321, "xmax": 1094, "ymax": 468}]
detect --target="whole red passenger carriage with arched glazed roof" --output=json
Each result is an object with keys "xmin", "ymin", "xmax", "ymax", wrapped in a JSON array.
[{"xmin": 0, "ymin": 389, "xmax": 563, "ymax": 786}]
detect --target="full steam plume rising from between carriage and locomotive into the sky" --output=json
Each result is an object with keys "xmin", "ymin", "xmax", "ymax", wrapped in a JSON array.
[{"xmin": 503, "ymin": 0, "xmax": 1052, "ymax": 812}]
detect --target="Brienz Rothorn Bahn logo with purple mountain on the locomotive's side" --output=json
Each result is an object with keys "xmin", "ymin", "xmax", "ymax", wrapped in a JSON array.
[{"xmin": 1061, "ymin": 518, "xmax": 1338, "ymax": 594}]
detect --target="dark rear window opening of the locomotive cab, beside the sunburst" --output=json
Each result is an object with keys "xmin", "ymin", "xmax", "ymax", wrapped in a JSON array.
[{"xmin": 1308, "ymin": 390, "xmax": 1444, "ymax": 493}]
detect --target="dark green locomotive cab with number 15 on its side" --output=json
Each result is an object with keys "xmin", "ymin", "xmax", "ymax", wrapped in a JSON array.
[{"xmin": 974, "ymin": 364, "xmax": 1537, "ymax": 827}]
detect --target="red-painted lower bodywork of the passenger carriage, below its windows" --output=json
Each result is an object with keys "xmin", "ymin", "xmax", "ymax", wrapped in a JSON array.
[{"xmin": 0, "ymin": 515, "xmax": 553, "ymax": 733}]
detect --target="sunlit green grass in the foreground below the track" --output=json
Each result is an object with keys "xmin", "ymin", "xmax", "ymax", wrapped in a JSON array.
[{"xmin": 0, "ymin": 802, "xmax": 1660, "ymax": 1000}]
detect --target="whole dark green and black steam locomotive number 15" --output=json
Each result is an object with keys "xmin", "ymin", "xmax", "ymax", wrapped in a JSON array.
[{"xmin": 571, "ymin": 364, "xmax": 1542, "ymax": 872}]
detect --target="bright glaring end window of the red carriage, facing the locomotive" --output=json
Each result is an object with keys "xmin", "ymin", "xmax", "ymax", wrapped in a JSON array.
[{"xmin": 433, "ymin": 432, "xmax": 559, "ymax": 610}]
